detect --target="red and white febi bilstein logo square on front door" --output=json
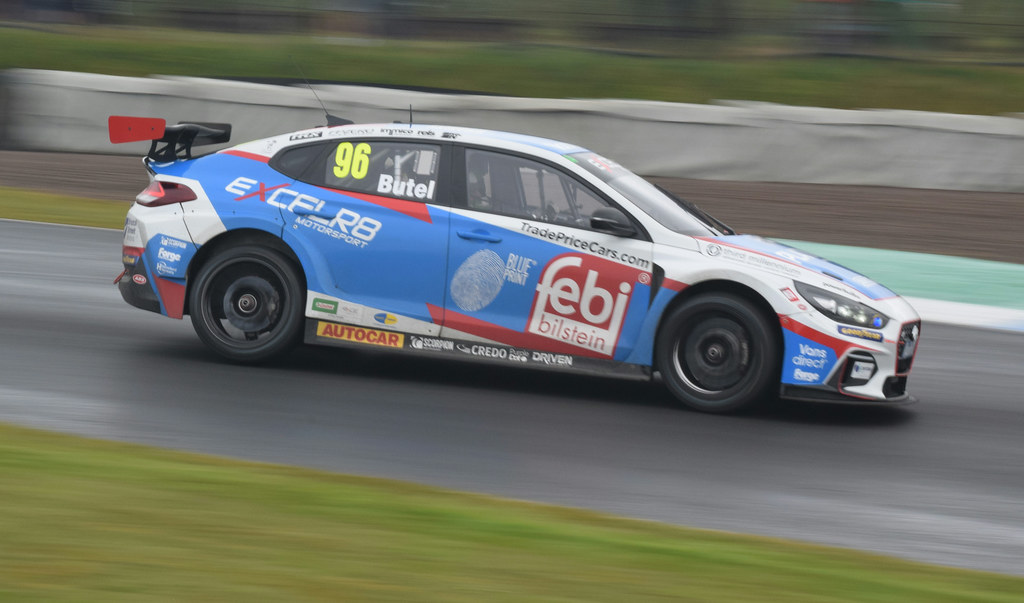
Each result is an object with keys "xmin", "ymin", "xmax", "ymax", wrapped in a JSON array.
[{"xmin": 526, "ymin": 254, "xmax": 646, "ymax": 357}]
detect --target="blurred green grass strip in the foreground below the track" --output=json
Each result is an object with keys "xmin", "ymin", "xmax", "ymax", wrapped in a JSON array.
[{"xmin": 0, "ymin": 425, "xmax": 1024, "ymax": 602}]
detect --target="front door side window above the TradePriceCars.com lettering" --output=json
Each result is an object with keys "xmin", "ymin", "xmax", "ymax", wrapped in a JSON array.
[{"xmin": 466, "ymin": 148, "xmax": 608, "ymax": 228}]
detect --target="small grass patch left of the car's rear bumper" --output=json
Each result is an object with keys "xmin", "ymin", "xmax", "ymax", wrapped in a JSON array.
[{"xmin": 0, "ymin": 186, "xmax": 130, "ymax": 228}]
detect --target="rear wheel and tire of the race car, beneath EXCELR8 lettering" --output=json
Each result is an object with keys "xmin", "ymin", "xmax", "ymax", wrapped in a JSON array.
[{"xmin": 188, "ymin": 245, "xmax": 305, "ymax": 362}]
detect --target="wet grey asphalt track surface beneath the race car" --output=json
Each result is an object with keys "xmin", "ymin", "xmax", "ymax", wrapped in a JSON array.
[{"xmin": 6, "ymin": 220, "xmax": 1024, "ymax": 575}]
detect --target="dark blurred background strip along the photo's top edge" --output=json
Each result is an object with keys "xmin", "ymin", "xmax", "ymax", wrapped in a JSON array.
[{"xmin": 6, "ymin": 0, "xmax": 1024, "ymax": 56}]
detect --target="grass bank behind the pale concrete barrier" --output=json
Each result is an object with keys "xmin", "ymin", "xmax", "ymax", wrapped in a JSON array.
[{"xmin": 0, "ymin": 26, "xmax": 1024, "ymax": 115}]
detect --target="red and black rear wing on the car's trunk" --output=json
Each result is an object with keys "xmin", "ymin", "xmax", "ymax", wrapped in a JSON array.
[{"xmin": 106, "ymin": 115, "xmax": 231, "ymax": 162}]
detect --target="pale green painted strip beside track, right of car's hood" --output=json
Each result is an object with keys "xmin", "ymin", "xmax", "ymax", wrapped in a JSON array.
[{"xmin": 778, "ymin": 240, "xmax": 1024, "ymax": 310}]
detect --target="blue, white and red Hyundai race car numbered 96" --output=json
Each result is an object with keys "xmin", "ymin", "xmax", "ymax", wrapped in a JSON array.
[{"xmin": 110, "ymin": 116, "xmax": 921, "ymax": 413}]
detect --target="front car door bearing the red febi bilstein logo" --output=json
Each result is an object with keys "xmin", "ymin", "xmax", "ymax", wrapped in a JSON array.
[{"xmin": 443, "ymin": 147, "xmax": 652, "ymax": 359}]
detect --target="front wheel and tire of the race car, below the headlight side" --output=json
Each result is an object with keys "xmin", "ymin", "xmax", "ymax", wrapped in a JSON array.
[{"xmin": 654, "ymin": 293, "xmax": 779, "ymax": 413}]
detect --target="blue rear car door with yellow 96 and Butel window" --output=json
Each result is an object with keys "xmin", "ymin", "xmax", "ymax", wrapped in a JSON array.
[{"xmin": 278, "ymin": 138, "xmax": 450, "ymax": 335}]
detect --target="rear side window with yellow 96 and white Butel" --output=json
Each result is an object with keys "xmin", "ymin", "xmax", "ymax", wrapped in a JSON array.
[{"xmin": 323, "ymin": 140, "xmax": 441, "ymax": 203}]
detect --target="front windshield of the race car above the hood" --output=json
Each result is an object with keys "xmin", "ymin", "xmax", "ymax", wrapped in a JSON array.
[{"xmin": 565, "ymin": 153, "xmax": 733, "ymax": 236}]
